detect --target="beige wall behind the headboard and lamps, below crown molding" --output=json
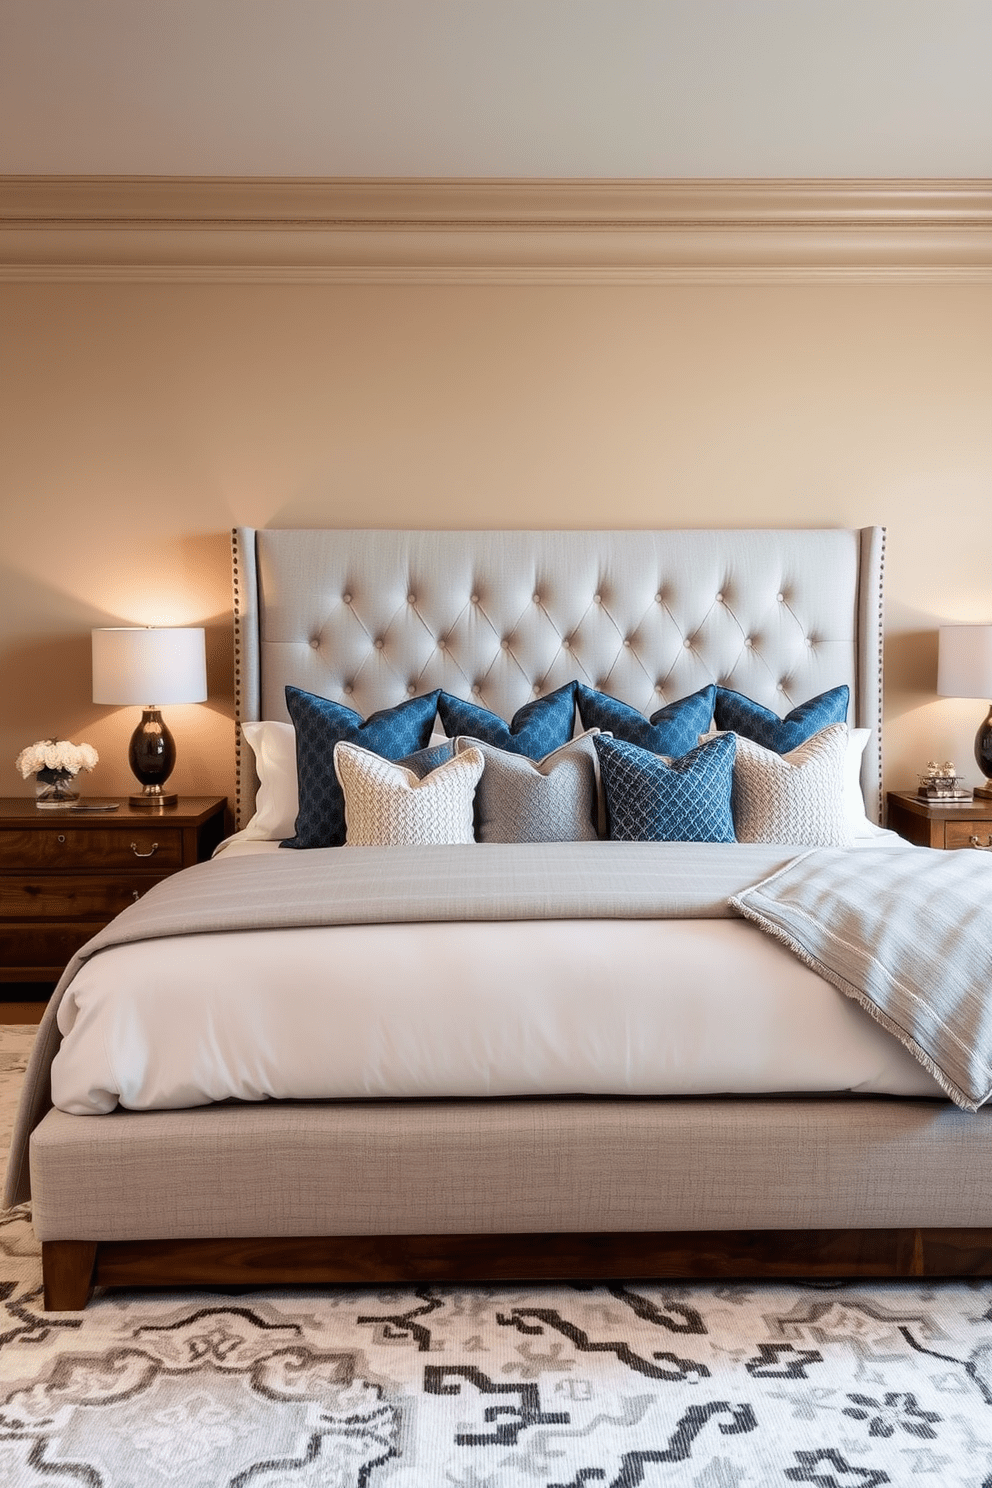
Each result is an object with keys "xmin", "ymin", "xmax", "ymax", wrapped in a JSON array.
[{"xmin": 0, "ymin": 283, "xmax": 992, "ymax": 815}]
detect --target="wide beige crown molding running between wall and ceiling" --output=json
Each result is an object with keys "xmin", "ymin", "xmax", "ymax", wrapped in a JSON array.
[{"xmin": 0, "ymin": 176, "xmax": 992, "ymax": 284}]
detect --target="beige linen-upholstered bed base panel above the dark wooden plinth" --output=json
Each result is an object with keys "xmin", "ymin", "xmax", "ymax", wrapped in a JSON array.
[{"xmin": 31, "ymin": 1097, "xmax": 992, "ymax": 1241}]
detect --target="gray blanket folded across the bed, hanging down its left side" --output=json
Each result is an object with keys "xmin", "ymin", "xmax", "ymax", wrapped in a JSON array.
[{"xmin": 4, "ymin": 842, "xmax": 794, "ymax": 1204}]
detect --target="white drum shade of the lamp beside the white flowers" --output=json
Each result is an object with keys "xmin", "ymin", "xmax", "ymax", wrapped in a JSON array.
[{"xmin": 92, "ymin": 625, "xmax": 207, "ymax": 707}]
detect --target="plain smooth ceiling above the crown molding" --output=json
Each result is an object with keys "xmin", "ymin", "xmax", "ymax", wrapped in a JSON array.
[{"xmin": 0, "ymin": 0, "xmax": 992, "ymax": 177}]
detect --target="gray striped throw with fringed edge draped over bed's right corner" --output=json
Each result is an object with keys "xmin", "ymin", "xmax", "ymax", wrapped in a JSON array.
[{"xmin": 732, "ymin": 845, "xmax": 992, "ymax": 1112}]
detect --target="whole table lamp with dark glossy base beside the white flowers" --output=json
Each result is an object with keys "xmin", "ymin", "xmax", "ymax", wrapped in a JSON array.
[{"xmin": 92, "ymin": 625, "xmax": 207, "ymax": 806}]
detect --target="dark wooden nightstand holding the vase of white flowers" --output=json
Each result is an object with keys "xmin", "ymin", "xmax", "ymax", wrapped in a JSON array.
[{"xmin": 0, "ymin": 796, "xmax": 228, "ymax": 982}]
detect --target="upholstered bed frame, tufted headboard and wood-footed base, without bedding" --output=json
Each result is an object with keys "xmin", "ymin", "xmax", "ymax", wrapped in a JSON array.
[{"xmin": 31, "ymin": 528, "xmax": 992, "ymax": 1308}]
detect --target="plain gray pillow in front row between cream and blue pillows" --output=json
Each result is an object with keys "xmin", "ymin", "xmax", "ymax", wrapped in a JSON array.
[{"xmin": 455, "ymin": 729, "xmax": 599, "ymax": 842}]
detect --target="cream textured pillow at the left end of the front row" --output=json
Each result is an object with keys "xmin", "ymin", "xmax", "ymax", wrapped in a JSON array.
[{"xmin": 335, "ymin": 740, "xmax": 483, "ymax": 847}]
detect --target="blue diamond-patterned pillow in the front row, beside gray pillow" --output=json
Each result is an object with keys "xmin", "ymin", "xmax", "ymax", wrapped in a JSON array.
[{"xmin": 593, "ymin": 734, "xmax": 738, "ymax": 842}]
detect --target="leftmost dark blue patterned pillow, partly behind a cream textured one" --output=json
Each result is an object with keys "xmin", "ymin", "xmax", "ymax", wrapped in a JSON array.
[{"xmin": 280, "ymin": 687, "xmax": 437, "ymax": 848}]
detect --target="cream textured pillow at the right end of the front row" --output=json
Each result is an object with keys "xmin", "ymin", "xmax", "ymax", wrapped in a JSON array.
[{"xmin": 733, "ymin": 723, "xmax": 854, "ymax": 847}]
